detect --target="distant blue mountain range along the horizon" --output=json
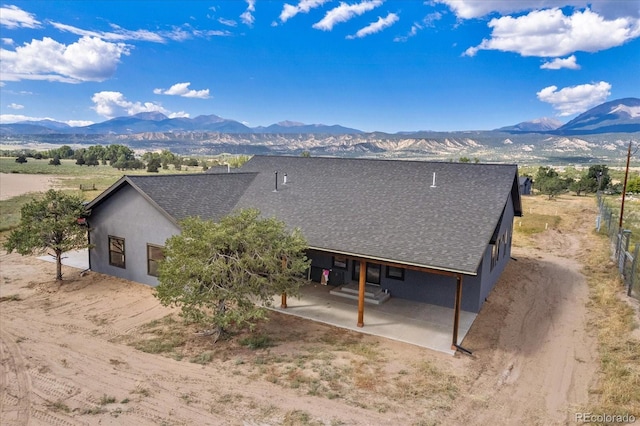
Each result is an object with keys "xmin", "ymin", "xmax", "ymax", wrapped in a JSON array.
[{"xmin": 0, "ymin": 98, "xmax": 640, "ymax": 137}]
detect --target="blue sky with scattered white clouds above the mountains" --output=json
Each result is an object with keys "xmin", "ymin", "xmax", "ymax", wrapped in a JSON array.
[{"xmin": 0, "ymin": 0, "xmax": 640, "ymax": 133}]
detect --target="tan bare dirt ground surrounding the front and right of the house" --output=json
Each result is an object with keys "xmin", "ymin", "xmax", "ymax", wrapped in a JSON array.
[{"xmin": 0, "ymin": 182, "xmax": 616, "ymax": 425}]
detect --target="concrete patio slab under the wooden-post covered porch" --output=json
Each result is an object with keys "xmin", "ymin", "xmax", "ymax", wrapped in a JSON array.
[{"xmin": 273, "ymin": 283, "xmax": 477, "ymax": 355}]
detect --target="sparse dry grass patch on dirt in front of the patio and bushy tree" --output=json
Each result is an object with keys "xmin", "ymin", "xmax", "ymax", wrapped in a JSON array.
[{"xmin": 127, "ymin": 312, "xmax": 462, "ymax": 424}]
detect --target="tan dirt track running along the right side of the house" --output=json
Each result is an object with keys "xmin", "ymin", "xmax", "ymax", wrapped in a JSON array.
[{"xmin": 448, "ymin": 198, "xmax": 597, "ymax": 425}]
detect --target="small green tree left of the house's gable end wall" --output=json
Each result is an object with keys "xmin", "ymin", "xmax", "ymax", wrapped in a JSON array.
[{"xmin": 4, "ymin": 189, "xmax": 89, "ymax": 280}]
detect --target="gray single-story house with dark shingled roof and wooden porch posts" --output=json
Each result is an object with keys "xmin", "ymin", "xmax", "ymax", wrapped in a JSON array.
[{"xmin": 88, "ymin": 156, "xmax": 522, "ymax": 345}]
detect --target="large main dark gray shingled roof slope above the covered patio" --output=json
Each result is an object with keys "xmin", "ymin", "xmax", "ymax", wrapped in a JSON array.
[{"xmin": 237, "ymin": 156, "xmax": 521, "ymax": 274}]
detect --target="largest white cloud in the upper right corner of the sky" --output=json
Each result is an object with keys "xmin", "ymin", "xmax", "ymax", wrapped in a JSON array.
[{"xmin": 465, "ymin": 9, "xmax": 640, "ymax": 57}]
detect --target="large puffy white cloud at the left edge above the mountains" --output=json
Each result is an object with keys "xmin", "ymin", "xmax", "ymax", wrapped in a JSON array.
[{"xmin": 0, "ymin": 37, "xmax": 130, "ymax": 83}]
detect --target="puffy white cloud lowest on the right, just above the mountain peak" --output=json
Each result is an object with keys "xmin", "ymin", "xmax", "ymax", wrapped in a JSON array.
[{"xmin": 536, "ymin": 81, "xmax": 611, "ymax": 117}]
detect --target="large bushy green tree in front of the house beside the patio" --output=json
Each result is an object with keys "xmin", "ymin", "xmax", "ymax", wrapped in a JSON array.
[{"xmin": 155, "ymin": 209, "xmax": 309, "ymax": 340}]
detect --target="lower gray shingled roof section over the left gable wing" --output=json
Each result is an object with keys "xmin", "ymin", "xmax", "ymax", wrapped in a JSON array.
[{"xmin": 87, "ymin": 173, "xmax": 256, "ymax": 222}]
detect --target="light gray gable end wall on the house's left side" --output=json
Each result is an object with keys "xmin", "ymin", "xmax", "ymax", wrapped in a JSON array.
[{"xmin": 89, "ymin": 185, "xmax": 180, "ymax": 286}]
